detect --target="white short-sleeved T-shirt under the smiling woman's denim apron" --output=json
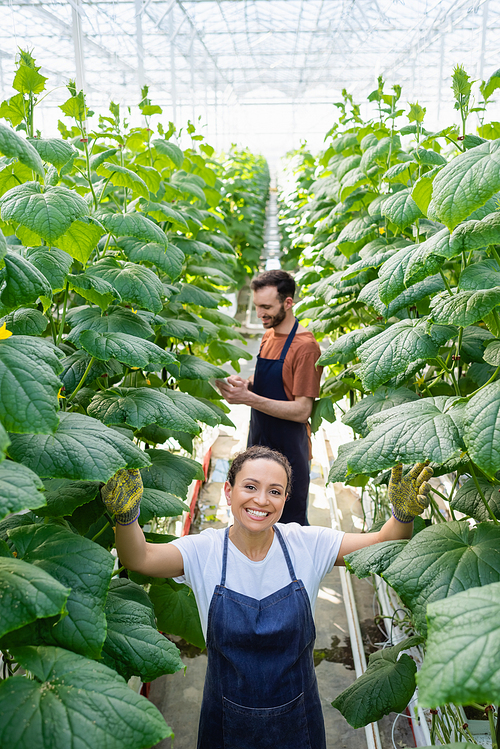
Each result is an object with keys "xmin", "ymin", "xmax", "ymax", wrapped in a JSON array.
[{"xmin": 171, "ymin": 523, "xmax": 344, "ymax": 638}]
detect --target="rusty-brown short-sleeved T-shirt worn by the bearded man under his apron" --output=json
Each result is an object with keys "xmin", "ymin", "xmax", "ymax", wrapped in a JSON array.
[{"xmin": 260, "ymin": 328, "xmax": 323, "ymax": 400}]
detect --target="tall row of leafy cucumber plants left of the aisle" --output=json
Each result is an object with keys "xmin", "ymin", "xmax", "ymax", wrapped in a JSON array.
[{"xmin": 0, "ymin": 52, "xmax": 265, "ymax": 749}]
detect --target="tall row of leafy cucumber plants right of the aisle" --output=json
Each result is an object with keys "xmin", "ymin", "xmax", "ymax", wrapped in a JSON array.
[{"xmin": 282, "ymin": 66, "xmax": 500, "ymax": 747}]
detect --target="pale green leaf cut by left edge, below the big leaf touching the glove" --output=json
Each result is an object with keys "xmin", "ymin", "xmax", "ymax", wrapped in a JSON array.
[{"xmin": 0, "ymin": 460, "xmax": 46, "ymax": 518}]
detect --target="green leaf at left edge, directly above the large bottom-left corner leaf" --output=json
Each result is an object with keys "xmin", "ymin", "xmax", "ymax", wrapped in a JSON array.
[{"xmin": 0, "ymin": 557, "xmax": 70, "ymax": 637}]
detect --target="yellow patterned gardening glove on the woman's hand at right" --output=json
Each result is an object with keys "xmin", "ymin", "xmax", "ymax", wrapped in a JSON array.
[{"xmin": 389, "ymin": 461, "xmax": 434, "ymax": 523}]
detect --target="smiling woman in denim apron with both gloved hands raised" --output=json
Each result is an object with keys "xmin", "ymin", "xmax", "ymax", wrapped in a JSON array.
[{"xmin": 103, "ymin": 446, "xmax": 432, "ymax": 749}]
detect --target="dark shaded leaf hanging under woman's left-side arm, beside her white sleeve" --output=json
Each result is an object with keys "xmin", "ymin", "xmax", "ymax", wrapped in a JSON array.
[{"xmin": 149, "ymin": 579, "xmax": 205, "ymax": 648}]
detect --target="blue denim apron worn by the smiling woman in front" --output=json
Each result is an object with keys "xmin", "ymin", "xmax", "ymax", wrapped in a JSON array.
[{"xmin": 198, "ymin": 526, "xmax": 326, "ymax": 749}]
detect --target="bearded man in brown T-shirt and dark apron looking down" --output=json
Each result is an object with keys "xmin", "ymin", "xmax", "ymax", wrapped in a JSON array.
[{"xmin": 217, "ymin": 270, "xmax": 322, "ymax": 525}]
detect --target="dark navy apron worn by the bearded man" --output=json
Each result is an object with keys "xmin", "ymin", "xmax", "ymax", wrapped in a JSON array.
[{"xmin": 247, "ymin": 320, "xmax": 309, "ymax": 525}]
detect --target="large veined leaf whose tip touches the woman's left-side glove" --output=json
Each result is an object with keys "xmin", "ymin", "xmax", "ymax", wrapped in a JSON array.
[{"xmin": 9, "ymin": 413, "xmax": 149, "ymax": 480}]
